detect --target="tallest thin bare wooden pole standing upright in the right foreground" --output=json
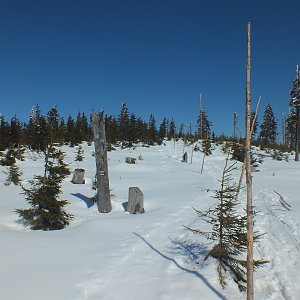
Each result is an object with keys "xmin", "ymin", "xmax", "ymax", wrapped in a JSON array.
[{"xmin": 245, "ymin": 22, "xmax": 254, "ymax": 300}]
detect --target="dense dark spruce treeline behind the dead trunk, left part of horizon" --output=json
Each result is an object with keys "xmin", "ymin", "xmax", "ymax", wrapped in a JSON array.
[{"xmin": 0, "ymin": 103, "xmax": 191, "ymax": 151}]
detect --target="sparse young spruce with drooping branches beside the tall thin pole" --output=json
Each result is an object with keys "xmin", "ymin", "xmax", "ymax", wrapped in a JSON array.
[{"xmin": 186, "ymin": 157, "xmax": 265, "ymax": 291}]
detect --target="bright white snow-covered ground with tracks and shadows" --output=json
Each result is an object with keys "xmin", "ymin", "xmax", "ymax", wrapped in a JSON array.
[{"xmin": 0, "ymin": 142, "xmax": 300, "ymax": 300}]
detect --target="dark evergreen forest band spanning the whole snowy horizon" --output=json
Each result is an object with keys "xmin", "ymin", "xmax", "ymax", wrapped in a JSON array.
[{"xmin": 0, "ymin": 98, "xmax": 296, "ymax": 155}]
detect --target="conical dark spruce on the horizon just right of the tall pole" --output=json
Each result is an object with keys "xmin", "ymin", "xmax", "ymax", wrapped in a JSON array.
[{"xmin": 259, "ymin": 103, "xmax": 277, "ymax": 146}]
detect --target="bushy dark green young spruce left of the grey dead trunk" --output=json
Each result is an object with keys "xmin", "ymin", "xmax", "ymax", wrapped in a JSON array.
[{"xmin": 16, "ymin": 145, "xmax": 72, "ymax": 230}]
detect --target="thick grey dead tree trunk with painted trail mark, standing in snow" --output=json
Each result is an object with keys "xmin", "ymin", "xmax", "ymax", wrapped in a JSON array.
[{"xmin": 92, "ymin": 111, "xmax": 112, "ymax": 213}]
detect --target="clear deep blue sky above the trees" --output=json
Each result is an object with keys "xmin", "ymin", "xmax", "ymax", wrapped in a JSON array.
[{"xmin": 0, "ymin": 0, "xmax": 300, "ymax": 134}]
